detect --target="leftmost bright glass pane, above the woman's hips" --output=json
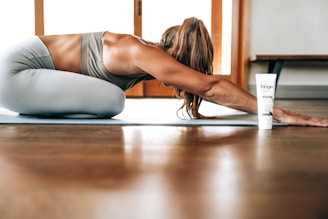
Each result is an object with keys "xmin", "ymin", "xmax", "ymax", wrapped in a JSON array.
[{"xmin": 0, "ymin": 0, "xmax": 34, "ymax": 50}]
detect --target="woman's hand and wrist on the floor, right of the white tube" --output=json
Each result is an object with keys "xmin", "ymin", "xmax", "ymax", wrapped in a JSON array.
[{"xmin": 273, "ymin": 107, "xmax": 328, "ymax": 127}]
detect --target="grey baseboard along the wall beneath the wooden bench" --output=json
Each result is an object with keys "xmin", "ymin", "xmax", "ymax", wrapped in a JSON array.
[{"xmin": 249, "ymin": 85, "xmax": 328, "ymax": 99}]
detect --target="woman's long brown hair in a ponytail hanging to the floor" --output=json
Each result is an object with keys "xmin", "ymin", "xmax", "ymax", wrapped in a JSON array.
[{"xmin": 161, "ymin": 17, "xmax": 213, "ymax": 119}]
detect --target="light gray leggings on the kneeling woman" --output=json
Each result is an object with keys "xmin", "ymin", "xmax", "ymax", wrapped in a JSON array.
[{"xmin": 0, "ymin": 37, "xmax": 125, "ymax": 117}]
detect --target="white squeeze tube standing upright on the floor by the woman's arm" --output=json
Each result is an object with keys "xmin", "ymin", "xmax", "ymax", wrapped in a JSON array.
[{"xmin": 255, "ymin": 73, "xmax": 277, "ymax": 129}]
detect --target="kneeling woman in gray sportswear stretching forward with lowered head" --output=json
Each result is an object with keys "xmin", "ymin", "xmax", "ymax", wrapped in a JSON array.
[{"xmin": 0, "ymin": 18, "xmax": 328, "ymax": 127}]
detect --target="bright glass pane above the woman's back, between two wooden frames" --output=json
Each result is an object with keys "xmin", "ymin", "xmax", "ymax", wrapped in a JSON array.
[{"xmin": 44, "ymin": 0, "xmax": 134, "ymax": 34}]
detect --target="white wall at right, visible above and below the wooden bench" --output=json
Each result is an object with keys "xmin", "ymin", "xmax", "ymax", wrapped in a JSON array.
[{"xmin": 249, "ymin": 0, "xmax": 328, "ymax": 98}]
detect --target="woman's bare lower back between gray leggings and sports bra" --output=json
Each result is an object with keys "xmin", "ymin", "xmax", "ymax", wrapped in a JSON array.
[{"xmin": 40, "ymin": 34, "xmax": 82, "ymax": 73}]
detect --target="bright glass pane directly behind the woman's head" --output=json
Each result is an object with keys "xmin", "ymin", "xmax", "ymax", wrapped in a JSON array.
[{"xmin": 142, "ymin": 0, "xmax": 212, "ymax": 42}]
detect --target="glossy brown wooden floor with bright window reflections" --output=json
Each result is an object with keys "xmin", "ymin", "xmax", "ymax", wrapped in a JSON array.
[{"xmin": 0, "ymin": 101, "xmax": 328, "ymax": 219}]
